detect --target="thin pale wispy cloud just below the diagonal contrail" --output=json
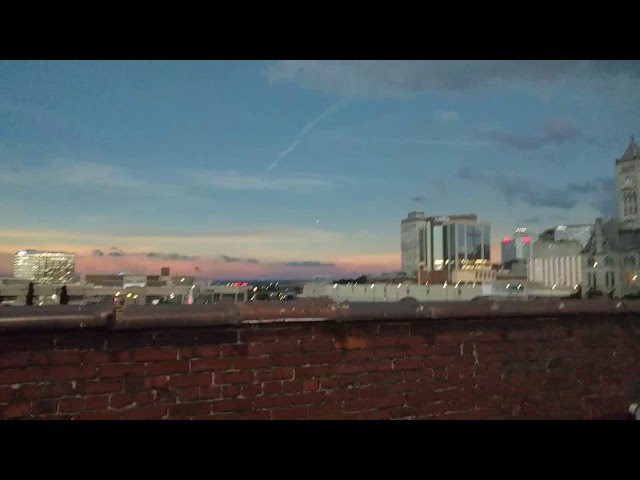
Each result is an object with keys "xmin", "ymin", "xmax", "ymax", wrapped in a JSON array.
[{"xmin": 196, "ymin": 171, "xmax": 349, "ymax": 193}]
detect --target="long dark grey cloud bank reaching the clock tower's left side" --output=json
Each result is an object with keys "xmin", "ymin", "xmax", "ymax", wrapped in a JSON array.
[{"xmin": 456, "ymin": 167, "xmax": 616, "ymax": 216}]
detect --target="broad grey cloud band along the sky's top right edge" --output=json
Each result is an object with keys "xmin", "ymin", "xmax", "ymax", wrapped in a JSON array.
[{"xmin": 267, "ymin": 60, "xmax": 640, "ymax": 96}]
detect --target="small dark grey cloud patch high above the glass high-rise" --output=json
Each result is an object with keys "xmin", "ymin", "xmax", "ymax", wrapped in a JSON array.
[{"xmin": 478, "ymin": 119, "xmax": 578, "ymax": 150}]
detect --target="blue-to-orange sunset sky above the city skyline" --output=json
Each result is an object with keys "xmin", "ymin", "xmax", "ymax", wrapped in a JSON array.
[{"xmin": 0, "ymin": 60, "xmax": 640, "ymax": 279}]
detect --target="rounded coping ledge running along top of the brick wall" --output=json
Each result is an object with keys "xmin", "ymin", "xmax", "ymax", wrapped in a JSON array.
[{"xmin": 0, "ymin": 299, "xmax": 640, "ymax": 333}]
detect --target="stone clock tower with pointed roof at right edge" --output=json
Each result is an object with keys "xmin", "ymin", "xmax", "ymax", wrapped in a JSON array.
[{"xmin": 616, "ymin": 136, "xmax": 640, "ymax": 230}]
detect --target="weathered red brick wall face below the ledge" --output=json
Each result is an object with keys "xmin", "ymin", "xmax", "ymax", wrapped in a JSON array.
[{"xmin": 0, "ymin": 316, "xmax": 640, "ymax": 420}]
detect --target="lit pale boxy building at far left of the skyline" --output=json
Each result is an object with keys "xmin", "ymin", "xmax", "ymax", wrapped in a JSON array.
[{"xmin": 13, "ymin": 250, "xmax": 76, "ymax": 284}]
